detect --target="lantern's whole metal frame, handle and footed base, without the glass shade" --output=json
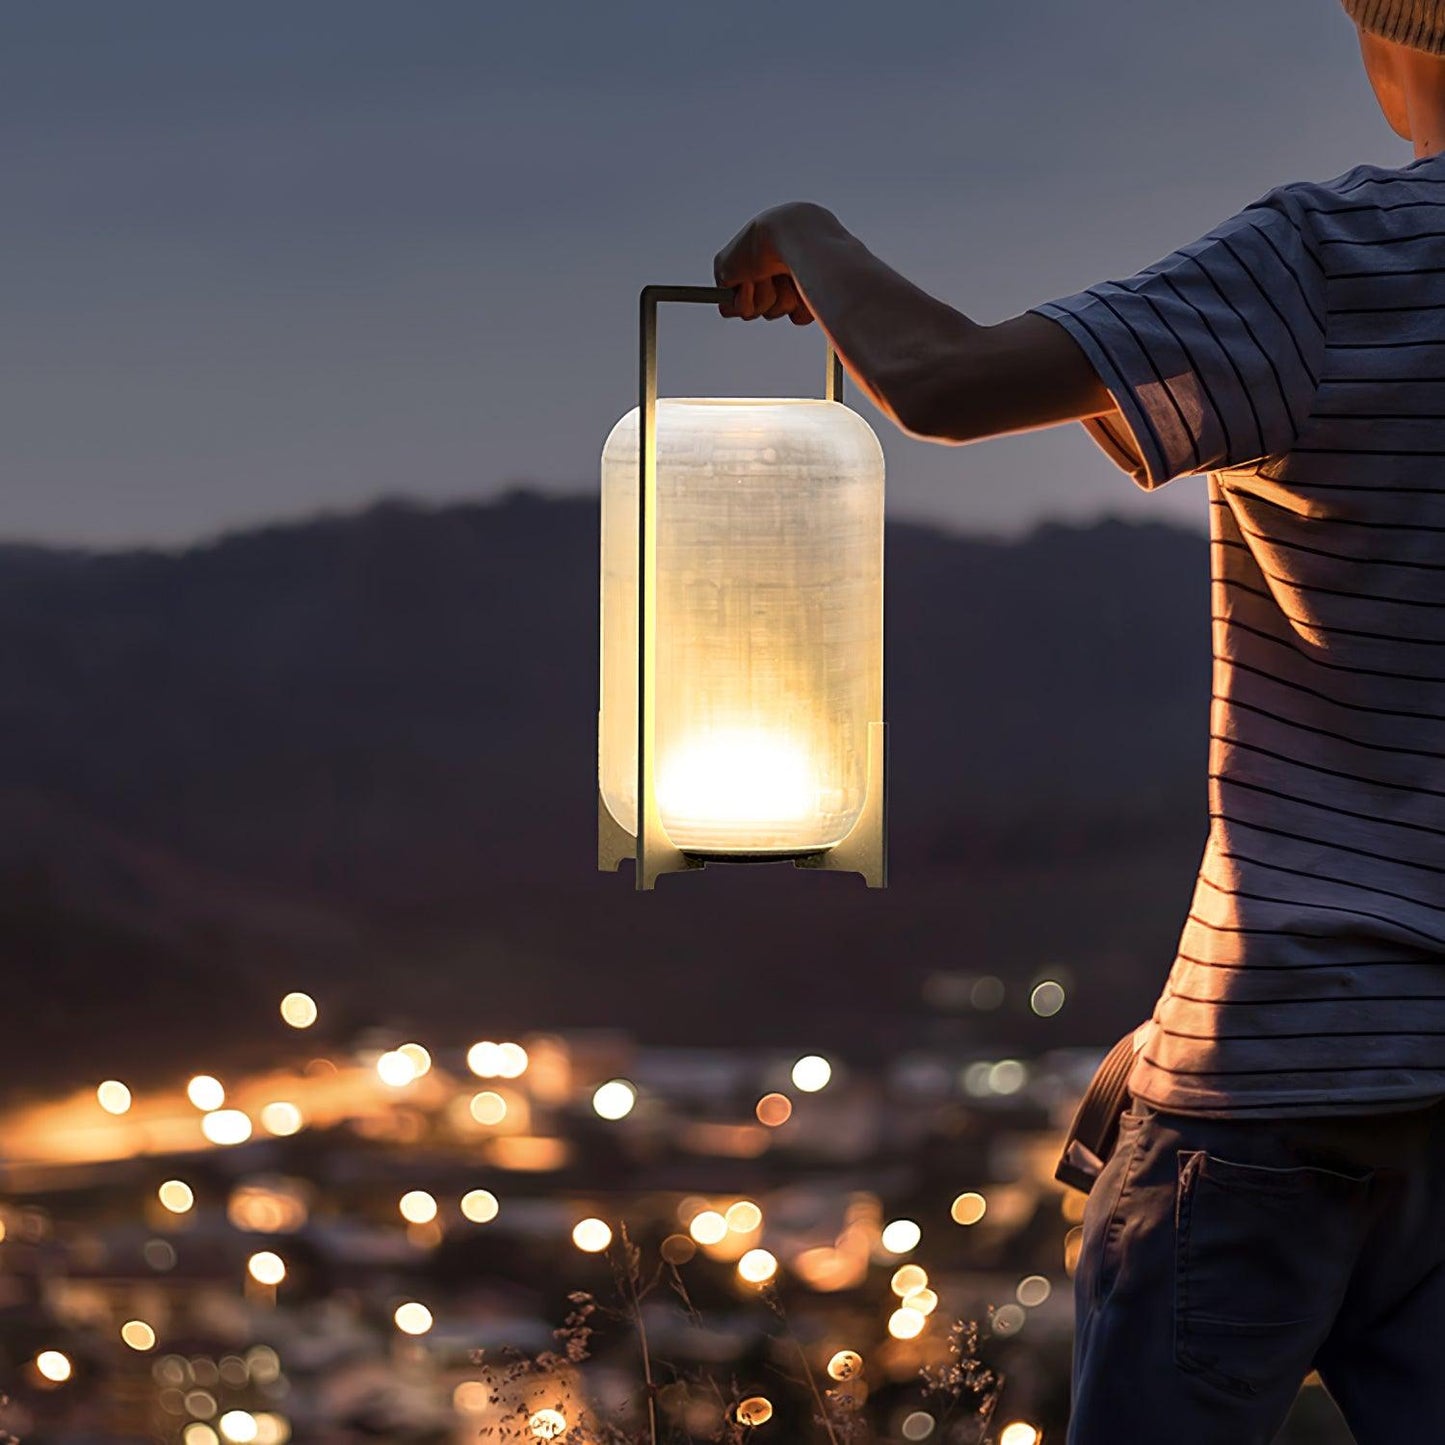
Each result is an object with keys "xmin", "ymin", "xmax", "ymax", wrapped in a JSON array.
[{"xmin": 597, "ymin": 286, "xmax": 887, "ymax": 892}]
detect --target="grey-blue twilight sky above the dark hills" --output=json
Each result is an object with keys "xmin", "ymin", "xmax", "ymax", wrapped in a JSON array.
[{"xmin": 0, "ymin": 0, "xmax": 1410, "ymax": 545}]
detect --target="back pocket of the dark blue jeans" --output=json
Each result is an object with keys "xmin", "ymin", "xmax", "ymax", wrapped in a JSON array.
[{"xmin": 1175, "ymin": 1150, "xmax": 1371, "ymax": 1394}]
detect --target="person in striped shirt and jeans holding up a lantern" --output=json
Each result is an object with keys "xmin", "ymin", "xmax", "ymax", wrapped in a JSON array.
[{"xmin": 714, "ymin": 0, "xmax": 1445, "ymax": 1445}]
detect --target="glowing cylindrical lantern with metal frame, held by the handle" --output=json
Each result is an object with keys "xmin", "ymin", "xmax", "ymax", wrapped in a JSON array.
[{"xmin": 597, "ymin": 286, "xmax": 886, "ymax": 889}]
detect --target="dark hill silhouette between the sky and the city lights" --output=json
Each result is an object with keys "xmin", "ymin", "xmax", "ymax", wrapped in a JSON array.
[{"xmin": 0, "ymin": 493, "xmax": 1209, "ymax": 1087}]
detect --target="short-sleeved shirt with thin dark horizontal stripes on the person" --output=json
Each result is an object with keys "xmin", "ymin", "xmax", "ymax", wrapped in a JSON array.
[{"xmin": 1038, "ymin": 156, "xmax": 1445, "ymax": 1117}]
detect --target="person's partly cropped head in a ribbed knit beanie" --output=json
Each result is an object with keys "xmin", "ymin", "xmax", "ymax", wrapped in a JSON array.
[{"xmin": 1344, "ymin": 0, "xmax": 1445, "ymax": 155}]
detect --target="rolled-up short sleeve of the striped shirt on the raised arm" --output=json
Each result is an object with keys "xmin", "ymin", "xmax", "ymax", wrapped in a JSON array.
[{"xmin": 1033, "ymin": 188, "xmax": 1325, "ymax": 488}]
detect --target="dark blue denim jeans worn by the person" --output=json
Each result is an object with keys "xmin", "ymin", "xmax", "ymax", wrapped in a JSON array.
[{"xmin": 1068, "ymin": 1100, "xmax": 1445, "ymax": 1445}]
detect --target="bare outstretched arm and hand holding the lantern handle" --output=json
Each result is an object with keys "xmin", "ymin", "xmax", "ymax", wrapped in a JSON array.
[{"xmin": 714, "ymin": 201, "xmax": 1116, "ymax": 442}]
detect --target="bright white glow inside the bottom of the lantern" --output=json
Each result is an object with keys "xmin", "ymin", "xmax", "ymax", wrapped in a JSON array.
[{"xmin": 657, "ymin": 727, "xmax": 822, "ymax": 834}]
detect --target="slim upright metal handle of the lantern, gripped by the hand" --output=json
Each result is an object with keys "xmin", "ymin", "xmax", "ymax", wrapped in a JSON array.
[{"xmin": 636, "ymin": 286, "xmax": 842, "ymax": 889}]
